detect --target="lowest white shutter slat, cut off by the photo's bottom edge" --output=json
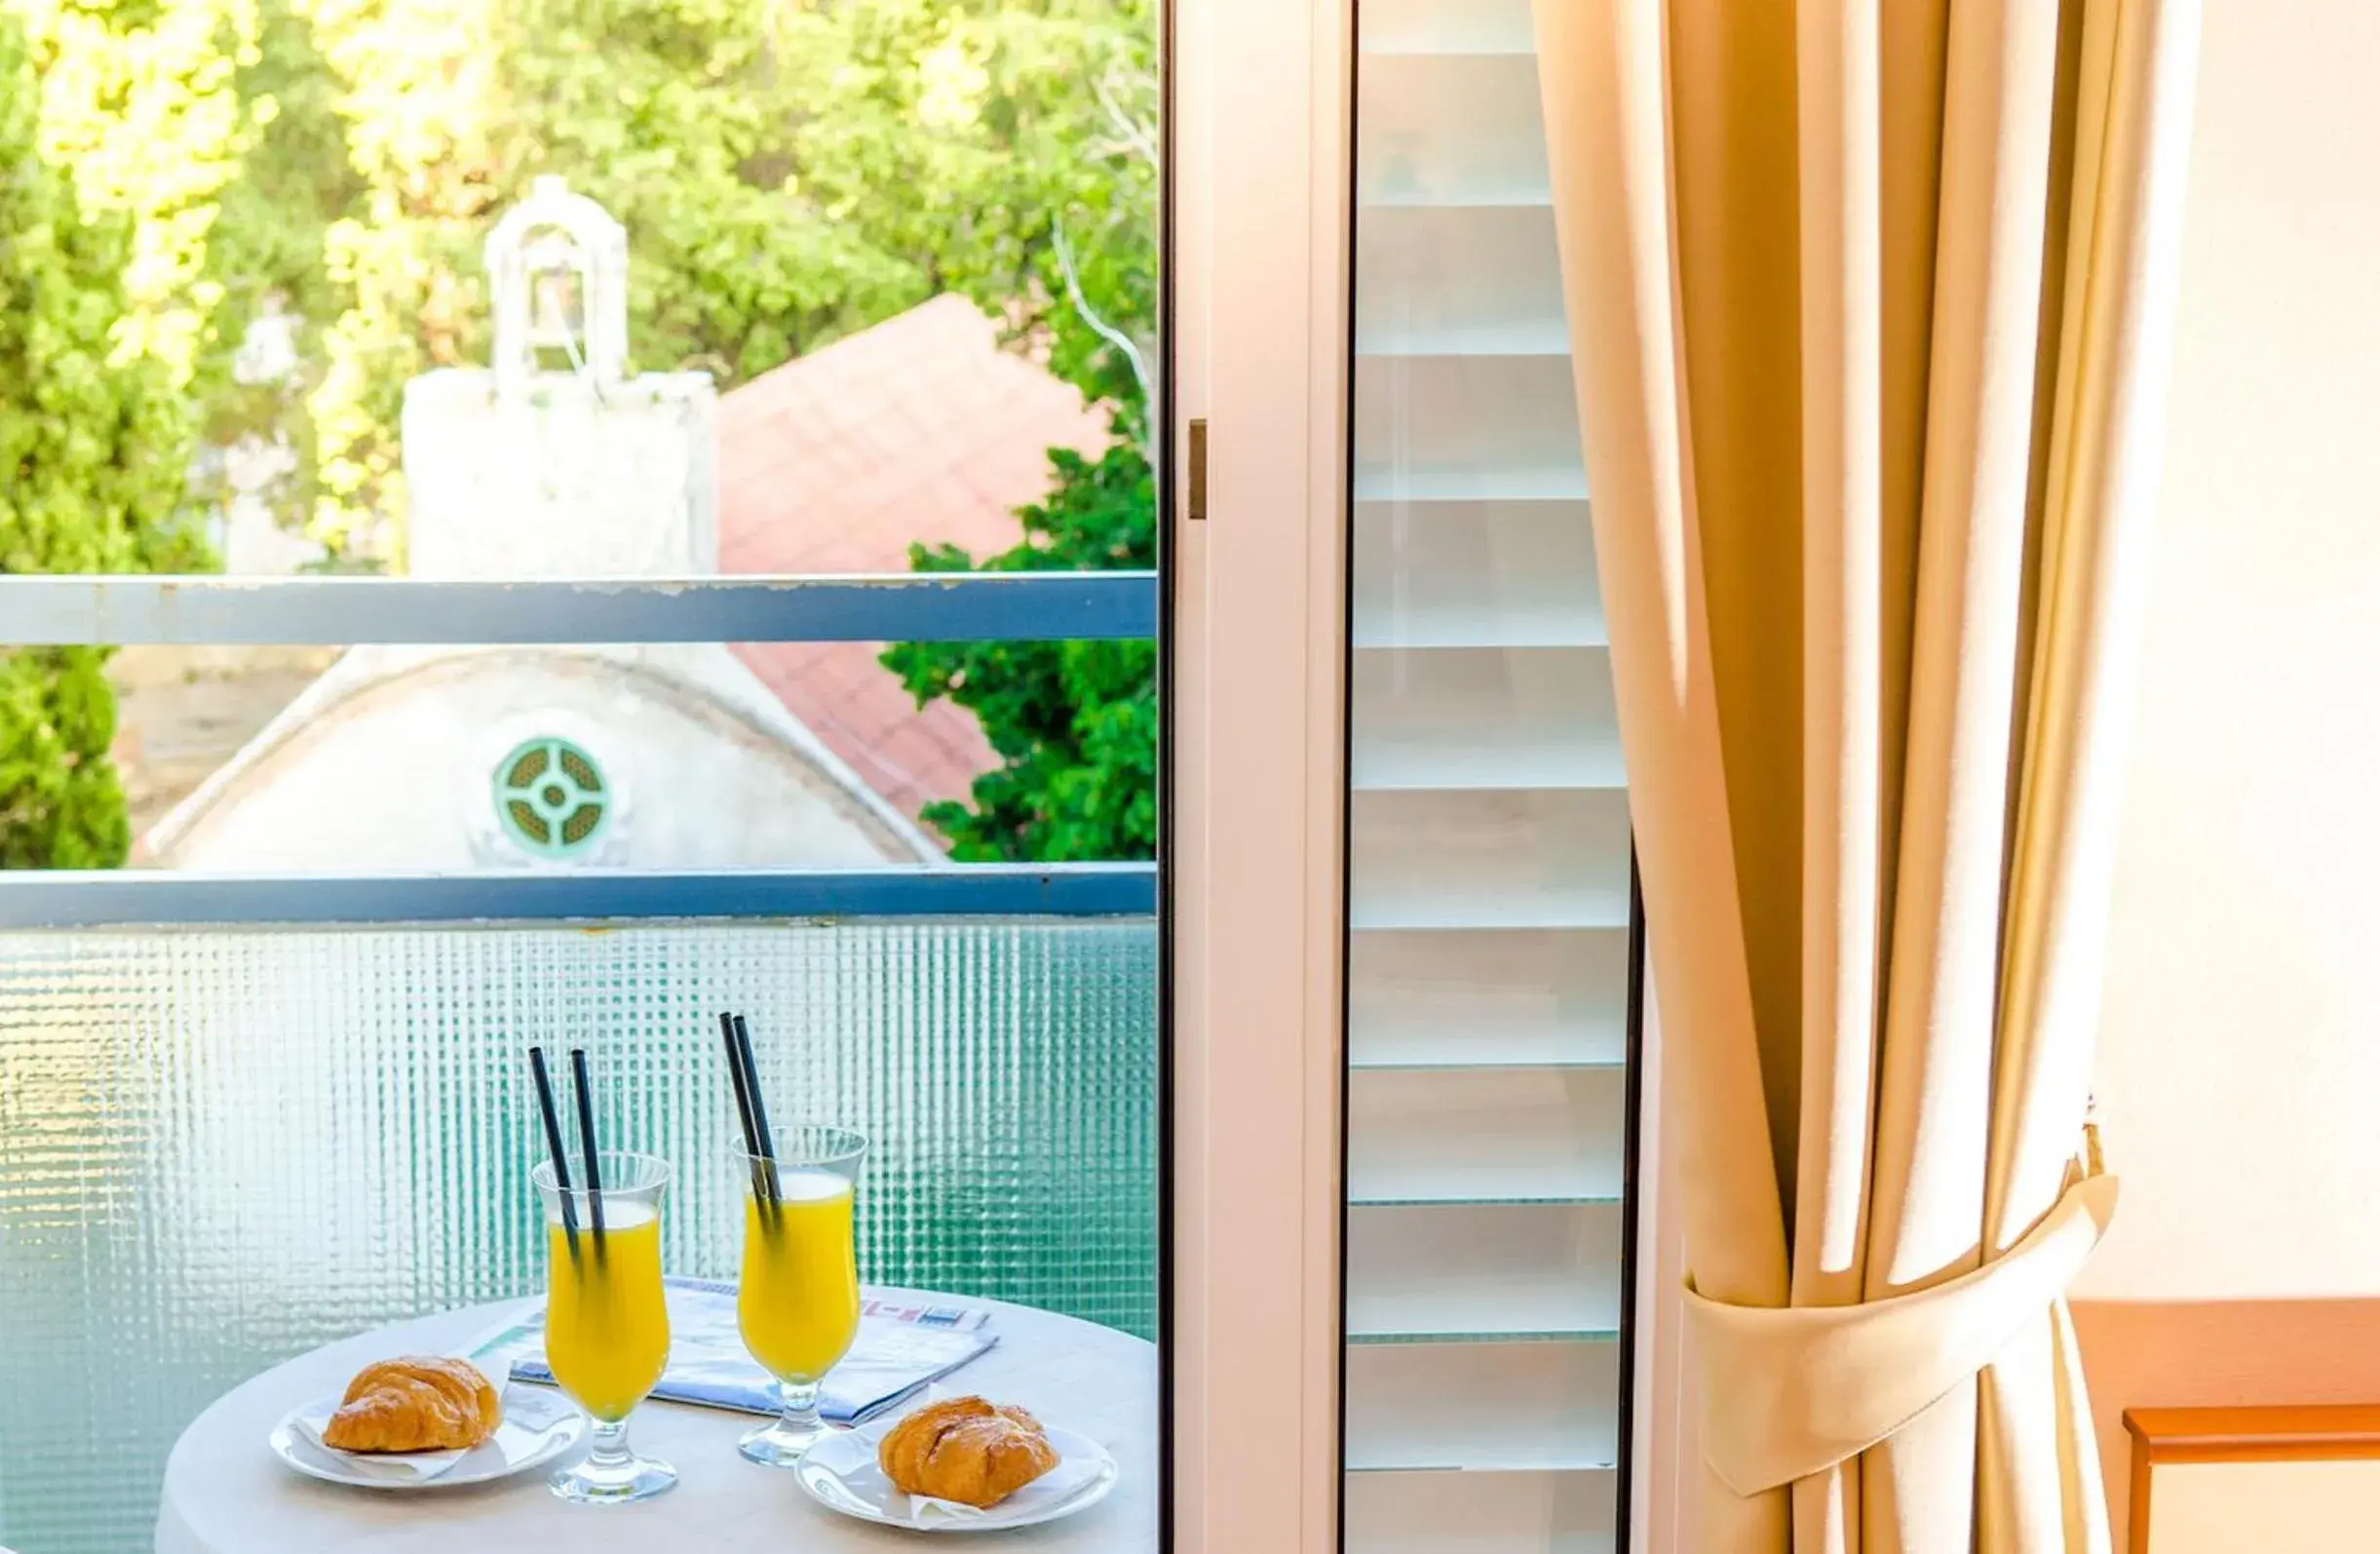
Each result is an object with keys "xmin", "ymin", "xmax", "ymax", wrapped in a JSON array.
[{"xmin": 1347, "ymin": 1468, "xmax": 1619, "ymax": 1554}]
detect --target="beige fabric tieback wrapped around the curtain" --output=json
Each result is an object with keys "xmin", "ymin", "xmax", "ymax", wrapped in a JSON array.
[{"xmin": 1685, "ymin": 1176, "xmax": 2116, "ymax": 1496}]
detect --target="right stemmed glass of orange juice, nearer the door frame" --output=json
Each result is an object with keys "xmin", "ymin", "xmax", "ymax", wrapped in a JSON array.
[{"xmin": 736, "ymin": 1123, "xmax": 868, "ymax": 1468}]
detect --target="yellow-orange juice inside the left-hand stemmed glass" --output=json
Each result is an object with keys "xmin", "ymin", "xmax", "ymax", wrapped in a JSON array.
[{"xmin": 545, "ymin": 1209, "xmax": 669, "ymax": 1423}]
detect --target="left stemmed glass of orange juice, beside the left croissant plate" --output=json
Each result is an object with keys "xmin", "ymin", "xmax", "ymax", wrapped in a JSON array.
[{"xmin": 531, "ymin": 1149, "xmax": 678, "ymax": 1504}]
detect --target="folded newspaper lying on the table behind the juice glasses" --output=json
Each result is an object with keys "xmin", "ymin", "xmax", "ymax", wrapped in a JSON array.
[{"xmin": 469, "ymin": 1278, "xmax": 1000, "ymax": 1425}]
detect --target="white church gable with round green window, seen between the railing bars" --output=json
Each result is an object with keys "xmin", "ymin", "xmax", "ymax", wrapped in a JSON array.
[{"xmin": 147, "ymin": 645, "xmax": 942, "ymax": 874}]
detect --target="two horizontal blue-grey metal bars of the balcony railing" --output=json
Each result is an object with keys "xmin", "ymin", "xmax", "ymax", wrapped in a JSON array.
[{"xmin": 0, "ymin": 571, "xmax": 1159, "ymax": 928}]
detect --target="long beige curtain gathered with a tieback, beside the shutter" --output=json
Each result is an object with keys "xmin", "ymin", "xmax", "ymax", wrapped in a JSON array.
[{"xmin": 1535, "ymin": 0, "xmax": 2197, "ymax": 1554}]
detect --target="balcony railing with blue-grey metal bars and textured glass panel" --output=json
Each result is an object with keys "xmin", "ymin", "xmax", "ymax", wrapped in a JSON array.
[{"xmin": 0, "ymin": 573, "xmax": 1162, "ymax": 1554}]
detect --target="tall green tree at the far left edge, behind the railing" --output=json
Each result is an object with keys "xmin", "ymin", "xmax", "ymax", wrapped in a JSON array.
[{"xmin": 0, "ymin": 10, "xmax": 203, "ymax": 869}]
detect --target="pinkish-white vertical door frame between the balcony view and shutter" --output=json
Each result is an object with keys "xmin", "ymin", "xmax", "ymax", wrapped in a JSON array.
[{"xmin": 1164, "ymin": 0, "xmax": 1354, "ymax": 1554}]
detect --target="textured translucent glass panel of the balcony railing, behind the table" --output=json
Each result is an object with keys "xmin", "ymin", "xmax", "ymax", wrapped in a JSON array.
[{"xmin": 0, "ymin": 921, "xmax": 1159, "ymax": 1554}]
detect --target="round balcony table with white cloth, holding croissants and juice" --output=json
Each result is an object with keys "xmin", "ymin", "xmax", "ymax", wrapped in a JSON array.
[{"xmin": 157, "ymin": 1290, "xmax": 1157, "ymax": 1554}]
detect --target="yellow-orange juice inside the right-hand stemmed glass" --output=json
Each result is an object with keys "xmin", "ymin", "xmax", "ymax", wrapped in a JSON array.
[{"xmin": 736, "ymin": 1169, "xmax": 860, "ymax": 1382}]
